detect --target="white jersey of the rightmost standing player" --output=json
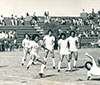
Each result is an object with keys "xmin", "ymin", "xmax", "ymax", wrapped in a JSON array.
[{"xmin": 67, "ymin": 36, "xmax": 78, "ymax": 52}]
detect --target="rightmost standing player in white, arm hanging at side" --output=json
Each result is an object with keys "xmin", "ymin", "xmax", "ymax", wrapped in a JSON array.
[{"xmin": 68, "ymin": 31, "xmax": 78, "ymax": 68}]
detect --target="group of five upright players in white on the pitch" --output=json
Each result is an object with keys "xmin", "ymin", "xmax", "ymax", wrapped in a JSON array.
[{"xmin": 22, "ymin": 30, "xmax": 78, "ymax": 77}]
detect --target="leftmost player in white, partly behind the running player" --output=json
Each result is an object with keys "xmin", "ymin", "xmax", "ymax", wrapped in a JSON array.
[{"xmin": 22, "ymin": 33, "xmax": 30, "ymax": 65}]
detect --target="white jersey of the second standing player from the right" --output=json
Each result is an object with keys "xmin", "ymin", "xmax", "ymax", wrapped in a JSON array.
[{"xmin": 58, "ymin": 39, "xmax": 70, "ymax": 55}]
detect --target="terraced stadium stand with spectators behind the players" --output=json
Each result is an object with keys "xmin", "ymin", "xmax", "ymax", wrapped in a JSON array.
[{"xmin": 0, "ymin": 12, "xmax": 100, "ymax": 50}]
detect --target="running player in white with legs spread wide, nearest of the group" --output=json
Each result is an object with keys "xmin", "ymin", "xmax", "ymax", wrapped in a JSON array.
[{"xmin": 27, "ymin": 35, "xmax": 46, "ymax": 77}]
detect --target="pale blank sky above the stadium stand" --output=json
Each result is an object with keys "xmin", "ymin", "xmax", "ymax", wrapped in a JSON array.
[{"xmin": 0, "ymin": 0, "xmax": 100, "ymax": 16}]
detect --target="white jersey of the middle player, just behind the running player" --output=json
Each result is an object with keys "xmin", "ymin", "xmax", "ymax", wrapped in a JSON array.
[{"xmin": 43, "ymin": 35, "xmax": 55, "ymax": 51}]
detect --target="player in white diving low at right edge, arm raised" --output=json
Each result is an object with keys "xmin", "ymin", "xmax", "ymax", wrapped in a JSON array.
[{"xmin": 85, "ymin": 53, "xmax": 100, "ymax": 80}]
